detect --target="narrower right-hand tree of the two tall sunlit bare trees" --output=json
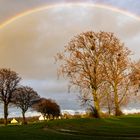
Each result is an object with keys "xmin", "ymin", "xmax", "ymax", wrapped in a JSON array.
[{"xmin": 103, "ymin": 35, "xmax": 131, "ymax": 116}]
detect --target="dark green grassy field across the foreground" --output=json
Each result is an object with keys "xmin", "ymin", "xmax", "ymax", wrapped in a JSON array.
[{"xmin": 0, "ymin": 115, "xmax": 140, "ymax": 140}]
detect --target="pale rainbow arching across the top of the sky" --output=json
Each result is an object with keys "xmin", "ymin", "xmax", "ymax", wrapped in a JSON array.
[{"xmin": 0, "ymin": 3, "xmax": 140, "ymax": 29}]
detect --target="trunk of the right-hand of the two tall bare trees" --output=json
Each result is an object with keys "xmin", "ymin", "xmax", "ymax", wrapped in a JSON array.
[{"xmin": 114, "ymin": 85, "xmax": 122, "ymax": 116}]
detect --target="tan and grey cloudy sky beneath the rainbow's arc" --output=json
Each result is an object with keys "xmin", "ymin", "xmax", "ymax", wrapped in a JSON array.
[{"xmin": 0, "ymin": 7, "xmax": 140, "ymax": 109}]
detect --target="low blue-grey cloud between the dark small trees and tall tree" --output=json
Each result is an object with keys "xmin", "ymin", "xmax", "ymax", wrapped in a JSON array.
[{"xmin": 21, "ymin": 79, "xmax": 81, "ymax": 110}]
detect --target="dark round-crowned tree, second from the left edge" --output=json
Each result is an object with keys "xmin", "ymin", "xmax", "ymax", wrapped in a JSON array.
[{"xmin": 12, "ymin": 86, "xmax": 40, "ymax": 124}]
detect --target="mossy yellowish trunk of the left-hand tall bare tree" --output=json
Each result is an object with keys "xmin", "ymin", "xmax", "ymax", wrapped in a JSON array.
[{"xmin": 93, "ymin": 90, "xmax": 101, "ymax": 118}]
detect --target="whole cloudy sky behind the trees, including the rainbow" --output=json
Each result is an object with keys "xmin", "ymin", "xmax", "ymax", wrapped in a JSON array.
[{"xmin": 0, "ymin": 0, "xmax": 140, "ymax": 117}]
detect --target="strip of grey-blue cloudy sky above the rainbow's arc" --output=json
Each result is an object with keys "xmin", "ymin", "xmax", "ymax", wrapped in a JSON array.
[{"xmin": 0, "ymin": 0, "xmax": 140, "ymax": 23}]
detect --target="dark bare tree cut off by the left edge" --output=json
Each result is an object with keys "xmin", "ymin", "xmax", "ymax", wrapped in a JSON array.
[{"xmin": 0, "ymin": 68, "xmax": 21, "ymax": 125}]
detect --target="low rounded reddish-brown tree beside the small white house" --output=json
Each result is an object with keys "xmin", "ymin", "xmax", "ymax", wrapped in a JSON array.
[{"xmin": 32, "ymin": 98, "xmax": 60, "ymax": 118}]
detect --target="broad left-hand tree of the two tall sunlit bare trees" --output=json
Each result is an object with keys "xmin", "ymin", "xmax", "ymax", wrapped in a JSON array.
[{"xmin": 57, "ymin": 32, "xmax": 118, "ymax": 117}]
